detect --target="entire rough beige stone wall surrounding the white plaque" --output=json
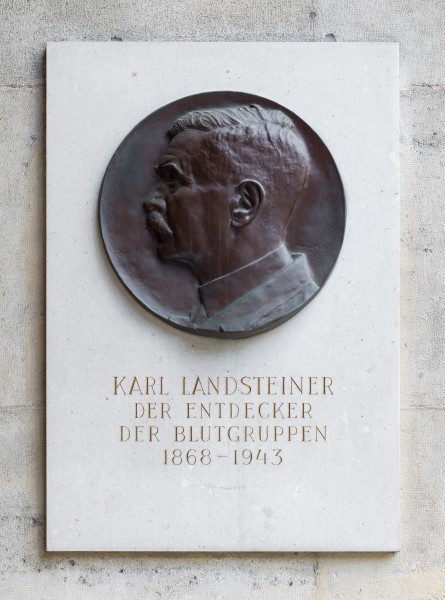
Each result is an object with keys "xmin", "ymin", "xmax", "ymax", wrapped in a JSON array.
[{"xmin": 0, "ymin": 0, "xmax": 445, "ymax": 600}]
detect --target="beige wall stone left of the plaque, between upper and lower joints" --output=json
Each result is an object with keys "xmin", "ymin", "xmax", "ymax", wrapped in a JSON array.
[{"xmin": 0, "ymin": 88, "xmax": 45, "ymax": 406}]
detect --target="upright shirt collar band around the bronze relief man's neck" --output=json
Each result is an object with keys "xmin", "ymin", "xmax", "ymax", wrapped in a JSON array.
[{"xmin": 198, "ymin": 244, "xmax": 292, "ymax": 317}]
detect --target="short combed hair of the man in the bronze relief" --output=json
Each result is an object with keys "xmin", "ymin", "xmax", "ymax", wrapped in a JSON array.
[{"xmin": 168, "ymin": 104, "xmax": 308, "ymax": 230}]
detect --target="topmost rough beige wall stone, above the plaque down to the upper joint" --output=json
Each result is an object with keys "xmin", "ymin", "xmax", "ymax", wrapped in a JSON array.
[{"xmin": 0, "ymin": 0, "xmax": 445, "ymax": 87}]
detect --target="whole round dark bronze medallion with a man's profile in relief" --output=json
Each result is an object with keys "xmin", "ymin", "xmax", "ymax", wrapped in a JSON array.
[{"xmin": 100, "ymin": 92, "xmax": 345, "ymax": 338}]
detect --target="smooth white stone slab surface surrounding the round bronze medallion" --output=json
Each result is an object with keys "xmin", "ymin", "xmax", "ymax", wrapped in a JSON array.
[{"xmin": 47, "ymin": 43, "xmax": 399, "ymax": 552}]
